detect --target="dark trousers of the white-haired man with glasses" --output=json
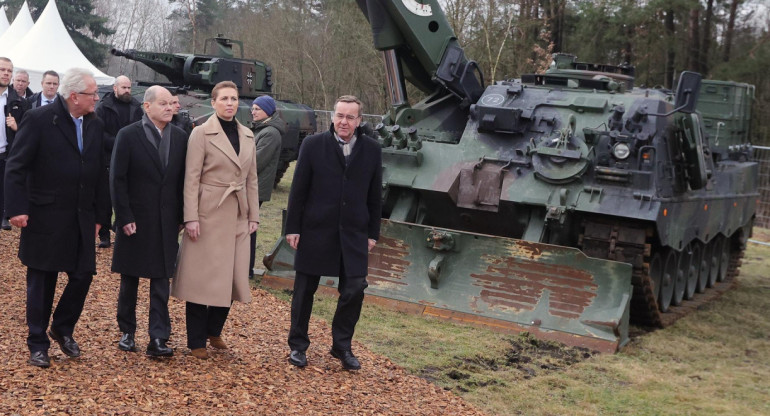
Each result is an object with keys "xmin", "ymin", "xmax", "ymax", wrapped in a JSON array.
[{"xmin": 27, "ymin": 268, "xmax": 93, "ymax": 352}]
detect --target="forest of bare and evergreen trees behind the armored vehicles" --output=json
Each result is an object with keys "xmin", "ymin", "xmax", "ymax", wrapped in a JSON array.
[{"xmin": 0, "ymin": 0, "xmax": 770, "ymax": 145}]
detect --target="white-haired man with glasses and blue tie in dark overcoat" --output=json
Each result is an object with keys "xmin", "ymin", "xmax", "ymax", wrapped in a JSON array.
[{"xmin": 5, "ymin": 68, "xmax": 110, "ymax": 367}]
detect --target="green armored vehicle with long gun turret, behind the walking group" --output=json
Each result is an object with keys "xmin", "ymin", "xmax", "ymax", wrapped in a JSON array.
[{"xmin": 110, "ymin": 35, "xmax": 316, "ymax": 184}]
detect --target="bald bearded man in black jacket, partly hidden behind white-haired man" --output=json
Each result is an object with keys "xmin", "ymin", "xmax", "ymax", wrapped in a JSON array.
[{"xmin": 96, "ymin": 75, "xmax": 144, "ymax": 248}]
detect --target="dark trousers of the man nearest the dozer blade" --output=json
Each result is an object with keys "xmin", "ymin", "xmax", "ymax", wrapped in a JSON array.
[{"xmin": 289, "ymin": 262, "xmax": 368, "ymax": 351}]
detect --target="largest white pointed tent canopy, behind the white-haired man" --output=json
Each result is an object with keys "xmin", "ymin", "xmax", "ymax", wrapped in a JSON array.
[{"xmin": 7, "ymin": 0, "xmax": 115, "ymax": 91}]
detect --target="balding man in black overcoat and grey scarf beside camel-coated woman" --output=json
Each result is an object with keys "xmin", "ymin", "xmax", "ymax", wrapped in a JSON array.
[{"xmin": 110, "ymin": 86, "xmax": 187, "ymax": 357}]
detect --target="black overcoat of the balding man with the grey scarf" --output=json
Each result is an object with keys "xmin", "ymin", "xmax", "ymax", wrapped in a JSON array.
[{"xmin": 110, "ymin": 121, "xmax": 187, "ymax": 278}]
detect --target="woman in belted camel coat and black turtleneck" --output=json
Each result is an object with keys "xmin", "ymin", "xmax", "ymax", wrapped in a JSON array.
[{"xmin": 171, "ymin": 81, "xmax": 259, "ymax": 359}]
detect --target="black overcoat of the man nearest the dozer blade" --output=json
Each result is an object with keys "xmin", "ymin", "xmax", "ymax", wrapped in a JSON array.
[{"xmin": 286, "ymin": 126, "xmax": 382, "ymax": 276}]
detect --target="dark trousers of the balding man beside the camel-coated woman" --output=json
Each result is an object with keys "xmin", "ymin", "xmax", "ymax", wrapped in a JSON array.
[{"xmin": 118, "ymin": 274, "xmax": 171, "ymax": 340}]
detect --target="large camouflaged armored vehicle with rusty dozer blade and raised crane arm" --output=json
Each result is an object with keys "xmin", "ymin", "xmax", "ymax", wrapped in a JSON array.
[{"xmin": 264, "ymin": 0, "xmax": 758, "ymax": 351}]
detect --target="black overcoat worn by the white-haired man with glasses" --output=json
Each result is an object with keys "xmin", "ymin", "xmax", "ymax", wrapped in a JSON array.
[{"xmin": 5, "ymin": 100, "xmax": 111, "ymax": 273}]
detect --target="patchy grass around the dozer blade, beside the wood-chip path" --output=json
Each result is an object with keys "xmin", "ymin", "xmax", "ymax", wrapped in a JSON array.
[{"xmin": 257, "ymin": 164, "xmax": 770, "ymax": 416}]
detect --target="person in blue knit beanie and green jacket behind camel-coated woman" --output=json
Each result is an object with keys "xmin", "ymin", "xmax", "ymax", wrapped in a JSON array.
[{"xmin": 249, "ymin": 95, "xmax": 286, "ymax": 279}]
